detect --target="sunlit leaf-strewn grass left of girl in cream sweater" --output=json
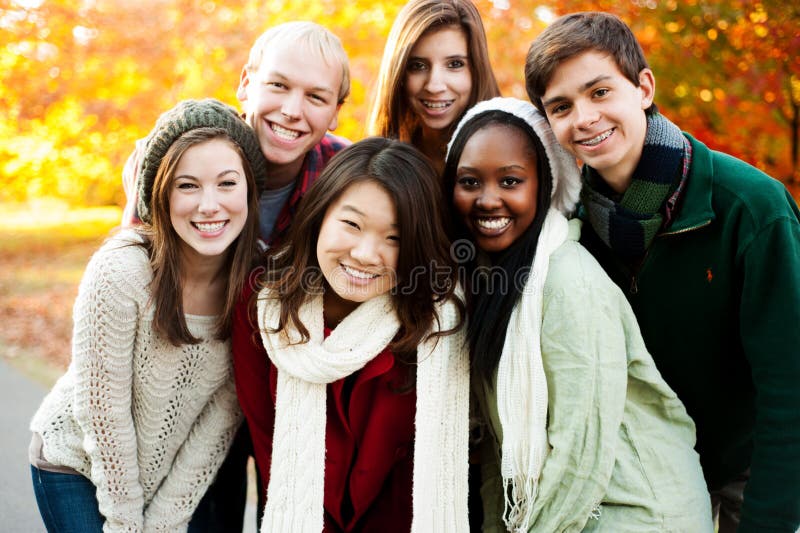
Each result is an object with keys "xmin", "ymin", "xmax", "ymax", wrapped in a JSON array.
[{"xmin": 0, "ymin": 200, "xmax": 121, "ymax": 387}]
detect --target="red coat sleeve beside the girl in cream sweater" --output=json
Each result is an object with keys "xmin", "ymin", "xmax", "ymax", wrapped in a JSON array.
[{"xmin": 231, "ymin": 276, "xmax": 275, "ymax": 494}]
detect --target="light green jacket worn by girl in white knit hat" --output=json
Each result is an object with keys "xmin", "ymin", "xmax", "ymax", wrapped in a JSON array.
[{"xmin": 474, "ymin": 220, "xmax": 713, "ymax": 533}]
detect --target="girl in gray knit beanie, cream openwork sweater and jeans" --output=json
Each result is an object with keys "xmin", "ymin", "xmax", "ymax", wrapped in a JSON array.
[{"xmin": 30, "ymin": 100, "xmax": 266, "ymax": 533}]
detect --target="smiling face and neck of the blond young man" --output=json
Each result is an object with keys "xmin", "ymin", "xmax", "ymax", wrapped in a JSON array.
[{"xmin": 237, "ymin": 45, "xmax": 342, "ymax": 188}]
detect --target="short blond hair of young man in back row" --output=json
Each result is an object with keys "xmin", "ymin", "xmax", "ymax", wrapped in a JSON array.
[{"xmin": 244, "ymin": 21, "xmax": 350, "ymax": 104}]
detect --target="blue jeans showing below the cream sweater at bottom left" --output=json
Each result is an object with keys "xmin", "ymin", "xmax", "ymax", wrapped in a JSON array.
[{"xmin": 31, "ymin": 466, "xmax": 105, "ymax": 533}]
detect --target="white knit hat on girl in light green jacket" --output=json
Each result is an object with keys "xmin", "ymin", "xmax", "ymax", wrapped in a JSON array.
[{"xmin": 447, "ymin": 96, "xmax": 581, "ymax": 216}]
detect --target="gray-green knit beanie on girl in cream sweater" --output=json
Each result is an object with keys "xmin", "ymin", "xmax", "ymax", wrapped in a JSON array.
[{"xmin": 136, "ymin": 98, "xmax": 267, "ymax": 223}]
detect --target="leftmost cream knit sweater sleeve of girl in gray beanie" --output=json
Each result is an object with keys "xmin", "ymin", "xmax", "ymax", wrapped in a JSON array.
[{"xmin": 71, "ymin": 245, "xmax": 144, "ymax": 532}]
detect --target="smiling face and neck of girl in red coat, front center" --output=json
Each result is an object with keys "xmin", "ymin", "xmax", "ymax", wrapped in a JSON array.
[{"xmin": 317, "ymin": 181, "xmax": 400, "ymax": 322}]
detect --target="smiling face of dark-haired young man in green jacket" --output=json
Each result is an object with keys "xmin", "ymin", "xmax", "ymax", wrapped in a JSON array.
[{"xmin": 542, "ymin": 50, "xmax": 655, "ymax": 192}]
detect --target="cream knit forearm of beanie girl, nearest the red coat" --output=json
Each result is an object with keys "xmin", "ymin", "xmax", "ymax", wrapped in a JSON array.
[{"xmin": 144, "ymin": 376, "xmax": 242, "ymax": 532}]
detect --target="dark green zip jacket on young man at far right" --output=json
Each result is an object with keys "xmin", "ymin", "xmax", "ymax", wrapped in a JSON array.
[{"xmin": 581, "ymin": 135, "xmax": 800, "ymax": 533}]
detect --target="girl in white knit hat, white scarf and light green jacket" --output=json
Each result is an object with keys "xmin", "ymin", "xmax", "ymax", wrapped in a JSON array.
[{"xmin": 444, "ymin": 98, "xmax": 712, "ymax": 533}]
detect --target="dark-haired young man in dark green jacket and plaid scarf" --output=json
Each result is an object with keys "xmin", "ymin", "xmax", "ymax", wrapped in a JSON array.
[{"xmin": 525, "ymin": 9, "xmax": 800, "ymax": 533}]
